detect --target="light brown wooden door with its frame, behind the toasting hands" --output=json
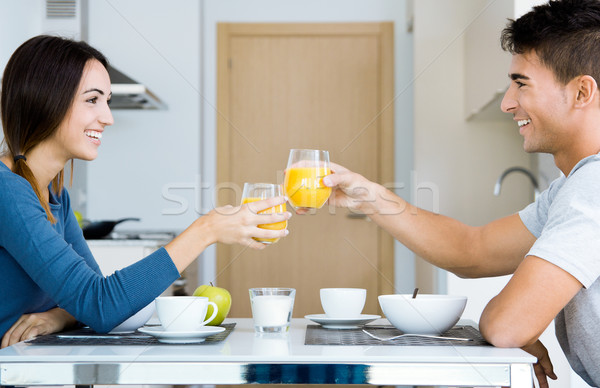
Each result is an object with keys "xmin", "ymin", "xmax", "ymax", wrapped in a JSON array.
[{"xmin": 216, "ymin": 23, "xmax": 393, "ymax": 317}]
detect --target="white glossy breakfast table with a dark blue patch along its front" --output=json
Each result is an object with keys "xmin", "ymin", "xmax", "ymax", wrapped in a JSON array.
[{"xmin": 0, "ymin": 318, "xmax": 535, "ymax": 388}]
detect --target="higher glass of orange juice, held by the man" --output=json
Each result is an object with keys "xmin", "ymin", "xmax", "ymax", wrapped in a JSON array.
[{"xmin": 283, "ymin": 149, "xmax": 331, "ymax": 210}]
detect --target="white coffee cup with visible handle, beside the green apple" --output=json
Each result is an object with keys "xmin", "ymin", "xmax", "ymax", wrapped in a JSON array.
[{"xmin": 155, "ymin": 296, "xmax": 219, "ymax": 331}]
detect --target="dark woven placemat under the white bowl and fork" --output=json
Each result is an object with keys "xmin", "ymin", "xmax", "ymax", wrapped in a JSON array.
[{"xmin": 304, "ymin": 325, "xmax": 492, "ymax": 346}]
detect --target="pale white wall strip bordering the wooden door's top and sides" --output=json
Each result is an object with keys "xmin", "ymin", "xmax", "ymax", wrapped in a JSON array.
[{"xmin": 201, "ymin": 0, "xmax": 414, "ymax": 292}]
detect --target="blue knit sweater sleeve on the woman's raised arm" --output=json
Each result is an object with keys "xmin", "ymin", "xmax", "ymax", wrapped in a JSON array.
[{"xmin": 0, "ymin": 171, "xmax": 179, "ymax": 334}]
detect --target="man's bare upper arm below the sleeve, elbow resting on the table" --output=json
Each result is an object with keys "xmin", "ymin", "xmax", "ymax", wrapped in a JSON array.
[{"xmin": 479, "ymin": 256, "xmax": 583, "ymax": 347}]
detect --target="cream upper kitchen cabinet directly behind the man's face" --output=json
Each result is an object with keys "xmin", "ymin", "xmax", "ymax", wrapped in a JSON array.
[{"xmin": 465, "ymin": 0, "xmax": 545, "ymax": 120}]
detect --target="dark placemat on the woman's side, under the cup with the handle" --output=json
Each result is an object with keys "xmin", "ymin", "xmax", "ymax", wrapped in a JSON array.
[{"xmin": 25, "ymin": 323, "xmax": 235, "ymax": 346}]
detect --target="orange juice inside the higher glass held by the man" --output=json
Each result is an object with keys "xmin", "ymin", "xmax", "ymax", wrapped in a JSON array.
[{"xmin": 284, "ymin": 167, "xmax": 331, "ymax": 209}]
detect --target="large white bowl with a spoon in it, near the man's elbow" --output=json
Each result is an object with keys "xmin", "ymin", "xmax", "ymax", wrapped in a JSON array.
[{"xmin": 378, "ymin": 294, "xmax": 467, "ymax": 334}]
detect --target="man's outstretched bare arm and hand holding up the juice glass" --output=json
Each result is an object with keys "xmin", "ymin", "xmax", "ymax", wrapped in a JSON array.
[{"xmin": 323, "ymin": 163, "xmax": 535, "ymax": 277}]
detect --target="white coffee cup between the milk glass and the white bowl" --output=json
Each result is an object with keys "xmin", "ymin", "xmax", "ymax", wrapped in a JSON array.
[{"xmin": 320, "ymin": 288, "xmax": 367, "ymax": 318}]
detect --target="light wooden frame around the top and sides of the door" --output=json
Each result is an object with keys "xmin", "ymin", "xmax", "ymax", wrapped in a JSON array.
[{"xmin": 215, "ymin": 22, "xmax": 395, "ymax": 295}]
